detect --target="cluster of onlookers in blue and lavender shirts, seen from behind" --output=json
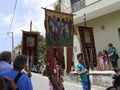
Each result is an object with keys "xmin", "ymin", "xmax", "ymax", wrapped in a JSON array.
[{"xmin": 0, "ymin": 51, "xmax": 33, "ymax": 90}]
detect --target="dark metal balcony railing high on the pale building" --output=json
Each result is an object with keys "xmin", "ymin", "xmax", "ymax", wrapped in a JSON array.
[{"xmin": 72, "ymin": 0, "xmax": 86, "ymax": 12}]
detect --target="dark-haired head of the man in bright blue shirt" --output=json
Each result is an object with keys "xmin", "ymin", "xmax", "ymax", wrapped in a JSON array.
[{"xmin": 13, "ymin": 55, "xmax": 27, "ymax": 71}]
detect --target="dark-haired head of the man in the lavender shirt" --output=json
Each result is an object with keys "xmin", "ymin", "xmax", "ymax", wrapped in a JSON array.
[{"xmin": 0, "ymin": 51, "xmax": 11, "ymax": 63}]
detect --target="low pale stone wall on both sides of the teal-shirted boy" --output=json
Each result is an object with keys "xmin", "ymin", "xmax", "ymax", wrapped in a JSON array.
[{"xmin": 64, "ymin": 71, "xmax": 114, "ymax": 87}]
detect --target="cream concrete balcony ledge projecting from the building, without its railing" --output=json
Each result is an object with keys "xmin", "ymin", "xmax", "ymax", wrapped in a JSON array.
[{"xmin": 72, "ymin": 0, "xmax": 120, "ymax": 24}]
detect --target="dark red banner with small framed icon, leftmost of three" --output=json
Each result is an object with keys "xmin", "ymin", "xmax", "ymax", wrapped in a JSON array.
[{"xmin": 22, "ymin": 31, "xmax": 38, "ymax": 66}]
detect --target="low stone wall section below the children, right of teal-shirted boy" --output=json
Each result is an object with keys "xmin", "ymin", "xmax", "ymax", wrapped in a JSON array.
[{"xmin": 89, "ymin": 71, "xmax": 114, "ymax": 87}]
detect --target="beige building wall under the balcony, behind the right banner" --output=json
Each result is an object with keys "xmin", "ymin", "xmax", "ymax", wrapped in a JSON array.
[{"xmin": 74, "ymin": 10, "xmax": 120, "ymax": 66}]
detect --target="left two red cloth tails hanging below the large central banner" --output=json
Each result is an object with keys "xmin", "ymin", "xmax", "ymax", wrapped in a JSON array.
[{"xmin": 46, "ymin": 46, "xmax": 63, "ymax": 76}]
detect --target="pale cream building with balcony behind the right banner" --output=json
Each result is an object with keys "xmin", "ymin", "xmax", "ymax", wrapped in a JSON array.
[{"xmin": 61, "ymin": 0, "xmax": 120, "ymax": 66}]
